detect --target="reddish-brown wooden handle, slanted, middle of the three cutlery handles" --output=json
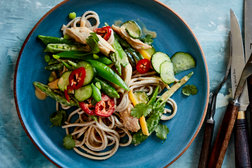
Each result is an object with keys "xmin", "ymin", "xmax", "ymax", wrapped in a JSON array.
[{"xmin": 208, "ymin": 102, "xmax": 239, "ymax": 168}]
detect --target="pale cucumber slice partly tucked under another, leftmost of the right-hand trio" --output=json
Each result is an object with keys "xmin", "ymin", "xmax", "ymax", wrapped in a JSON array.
[{"xmin": 151, "ymin": 52, "xmax": 171, "ymax": 73}]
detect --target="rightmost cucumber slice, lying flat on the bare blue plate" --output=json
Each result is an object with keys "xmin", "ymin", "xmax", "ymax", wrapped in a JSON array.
[{"xmin": 171, "ymin": 52, "xmax": 196, "ymax": 74}]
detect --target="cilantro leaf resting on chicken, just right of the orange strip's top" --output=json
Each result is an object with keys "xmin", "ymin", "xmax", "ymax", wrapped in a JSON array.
[{"xmin": 131, "ymin": 103, "xmax": 152, "ymax": 118}]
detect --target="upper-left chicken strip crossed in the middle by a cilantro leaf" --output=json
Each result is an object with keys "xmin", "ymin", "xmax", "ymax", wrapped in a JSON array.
[{"xmin": 66, "ymin": 27, "xmax": 115, "ymax": 56}]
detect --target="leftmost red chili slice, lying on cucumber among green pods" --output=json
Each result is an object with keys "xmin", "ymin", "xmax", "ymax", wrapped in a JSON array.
[{"xmin": 69, "ymin": 67, "xmax": 86, "ymax": 89}]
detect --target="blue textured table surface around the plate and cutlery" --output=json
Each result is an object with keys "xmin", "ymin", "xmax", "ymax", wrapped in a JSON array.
[{"xmin": 0, "ymin": 0, "xmax": 243, "ymax": 168}]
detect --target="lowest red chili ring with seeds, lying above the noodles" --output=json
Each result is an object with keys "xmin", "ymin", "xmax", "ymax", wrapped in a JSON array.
[{"xmin": 95, "ymin": 95, "xmax": 115, "ymax": 117}]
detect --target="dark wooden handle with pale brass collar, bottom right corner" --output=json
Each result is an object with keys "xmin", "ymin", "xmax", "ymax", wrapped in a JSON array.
[{"xmin": 235, "ymin": 111, "xmax": 251, "ymax": 168}]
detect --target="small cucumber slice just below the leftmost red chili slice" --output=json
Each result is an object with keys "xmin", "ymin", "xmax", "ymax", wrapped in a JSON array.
[{"xmin": 74, "ymin": 85, "xmax": 92, "ymax": 102}]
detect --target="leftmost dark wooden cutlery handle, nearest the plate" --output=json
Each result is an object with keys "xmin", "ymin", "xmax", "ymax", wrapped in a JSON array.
[{"xmin": 198, "ymin": 119, "xmax": 214, "ymax": 168}]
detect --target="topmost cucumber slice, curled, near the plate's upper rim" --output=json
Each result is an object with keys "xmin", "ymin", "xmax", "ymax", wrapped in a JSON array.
[{"xmin": 121, "ymin": 20, "xmax": 142, "ymax": 39}]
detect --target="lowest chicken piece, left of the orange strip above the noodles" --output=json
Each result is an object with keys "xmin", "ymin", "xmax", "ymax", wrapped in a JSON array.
[{"xmin": 120, "ymin": 108, "xmax": 140, "ymax": 132}]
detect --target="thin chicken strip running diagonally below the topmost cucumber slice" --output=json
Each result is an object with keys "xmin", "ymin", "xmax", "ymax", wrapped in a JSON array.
[{"xmin": 112, "ymin": 25, "xmax": 151, "ymax": 50}]
